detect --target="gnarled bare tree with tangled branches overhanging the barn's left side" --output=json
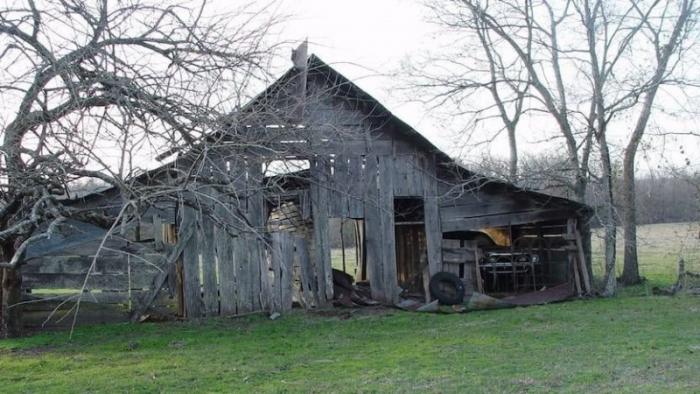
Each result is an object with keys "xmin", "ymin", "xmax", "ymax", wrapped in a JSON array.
[{"xmin": 0, "ymin": 0, "xmax": 276, "ymax": 335}]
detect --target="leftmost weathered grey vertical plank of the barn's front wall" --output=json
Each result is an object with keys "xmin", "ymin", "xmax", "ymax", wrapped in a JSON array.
[{"xmin": 180, "ymin": 205, "xmax": 203, "ymax": 319}]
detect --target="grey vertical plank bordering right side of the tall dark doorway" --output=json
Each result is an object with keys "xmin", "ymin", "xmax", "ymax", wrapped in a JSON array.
[{"xmin": 423, "ymin": 155, "xmax": 442, "ymax": 277}]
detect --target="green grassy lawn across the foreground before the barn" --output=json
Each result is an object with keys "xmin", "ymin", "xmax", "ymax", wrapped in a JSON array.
[{"xmin": 0, "ymin": 226, "xmax": 700, "ymax": 392}]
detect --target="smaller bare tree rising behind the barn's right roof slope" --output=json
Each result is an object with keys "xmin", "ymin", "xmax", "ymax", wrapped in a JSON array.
[{"xmin": 403, "ymin": 1, "xmax": 532, "ymax": 182}]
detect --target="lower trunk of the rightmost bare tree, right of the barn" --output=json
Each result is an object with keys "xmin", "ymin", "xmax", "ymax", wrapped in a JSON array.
[{"xmin": 621, "ymin": 161, "xmax": 641, "ymax": 285}]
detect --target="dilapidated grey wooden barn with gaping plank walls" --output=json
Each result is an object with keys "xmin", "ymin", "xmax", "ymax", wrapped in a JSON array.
[{"xmin": 22, "ymin": 46, "xmax": 590, "ymax": 325}]
